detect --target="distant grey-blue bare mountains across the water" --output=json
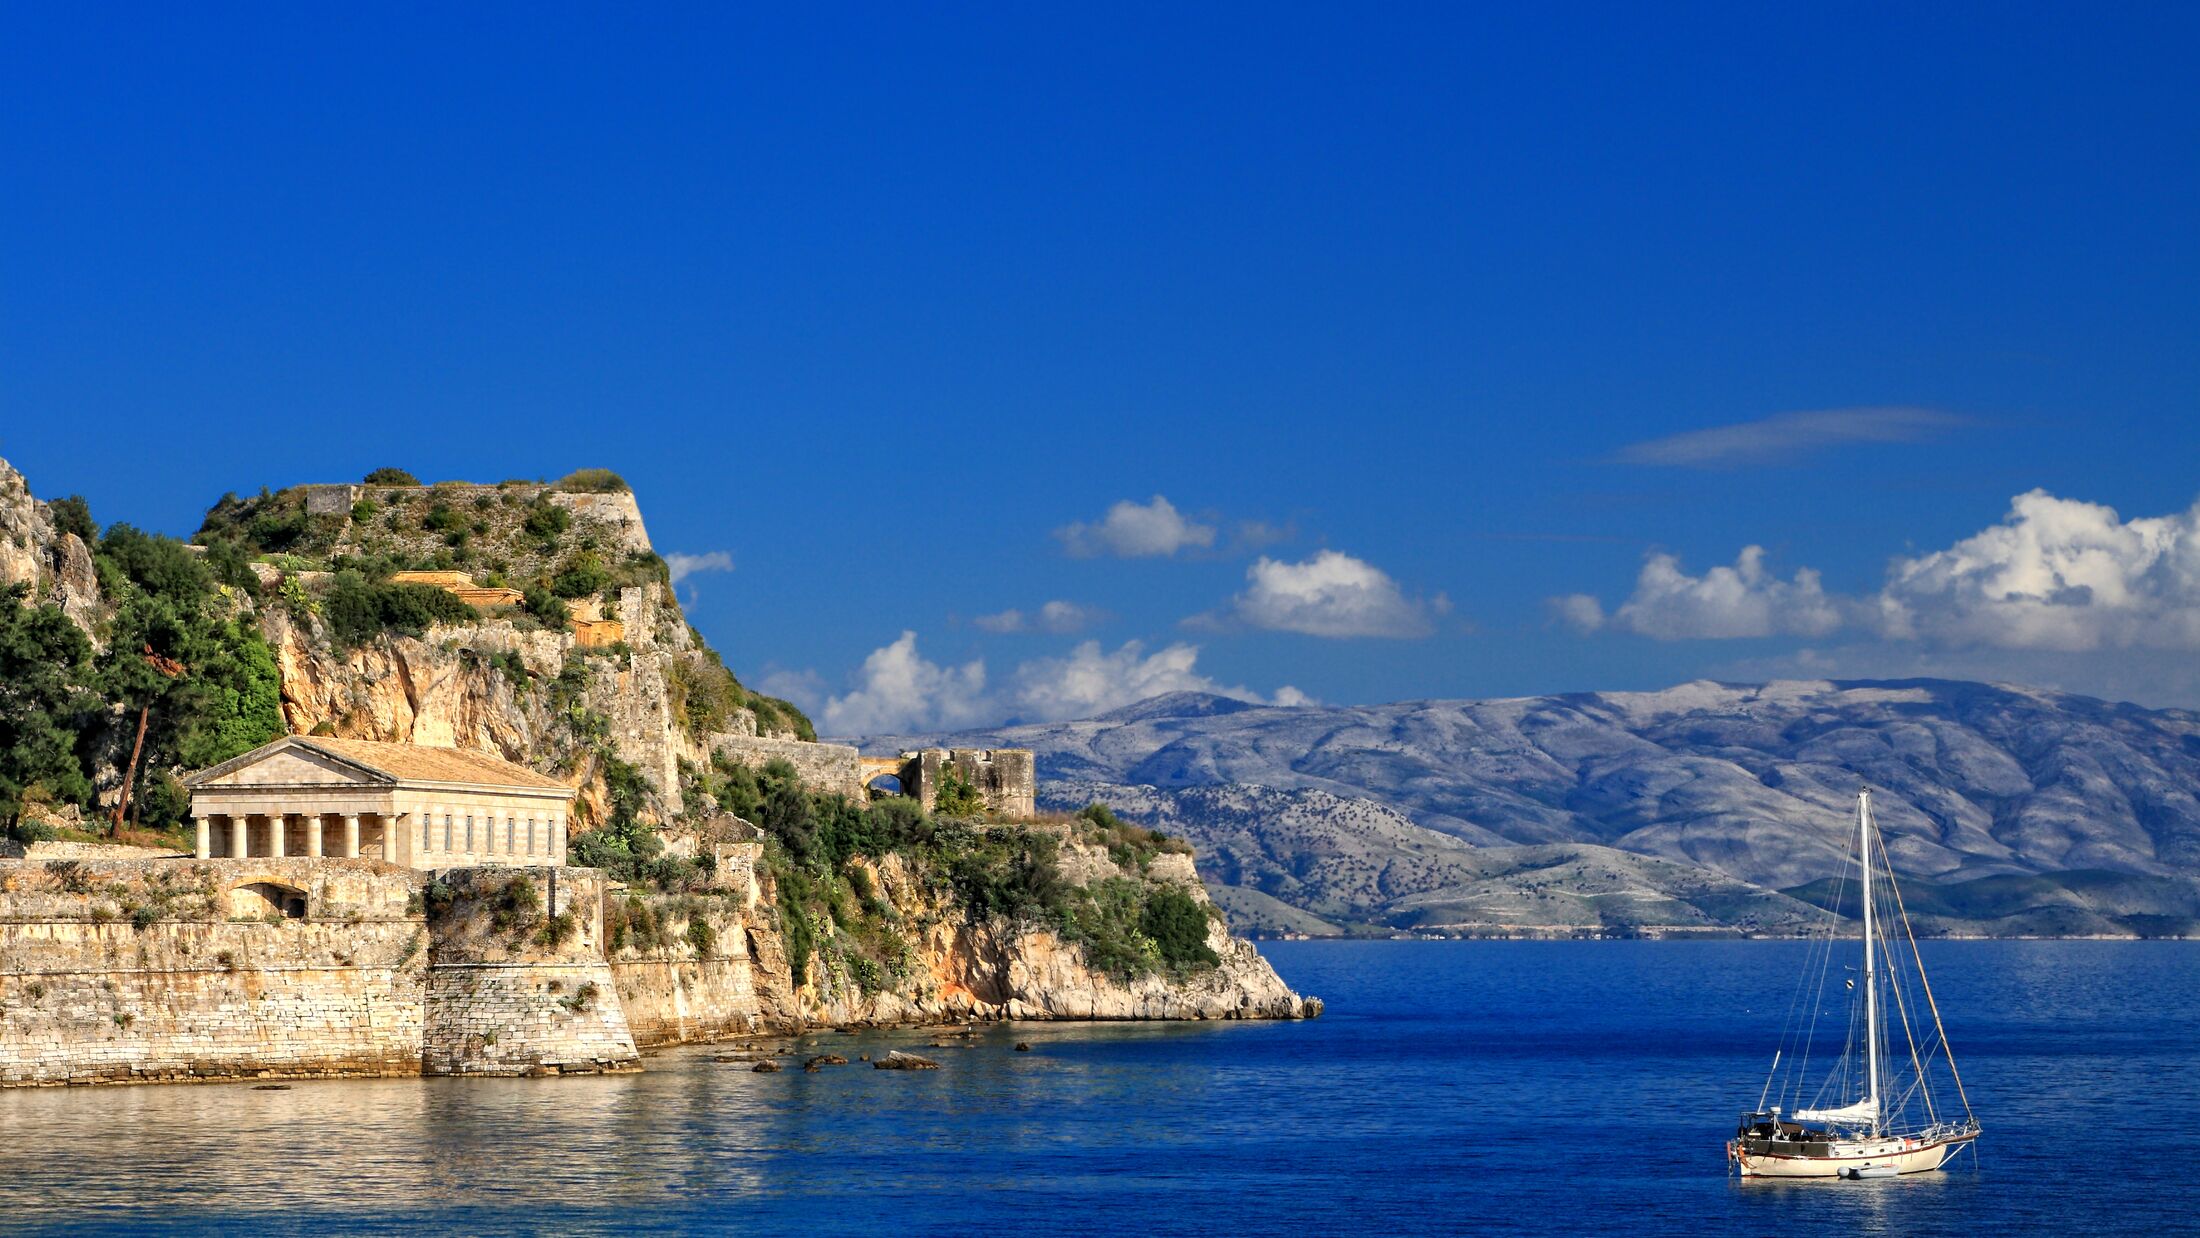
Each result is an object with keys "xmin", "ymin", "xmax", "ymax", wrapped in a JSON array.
[{"xmin": 865, "ymin": 679, "xmax": 2200, "ymax": 935}]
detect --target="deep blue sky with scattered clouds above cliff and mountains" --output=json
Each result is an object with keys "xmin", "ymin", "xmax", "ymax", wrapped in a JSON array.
[{"xmin": 0, "ymin": 4, "xmax": 2200, "ymax": 730}]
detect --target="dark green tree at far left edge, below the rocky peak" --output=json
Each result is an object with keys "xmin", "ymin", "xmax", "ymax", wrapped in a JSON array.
[{"xmin": 0, "ymin": 585, "xmax": 97, "ymax": 827}]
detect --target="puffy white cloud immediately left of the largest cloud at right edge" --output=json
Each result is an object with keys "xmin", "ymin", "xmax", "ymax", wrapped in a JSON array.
[{"xmin": 1601, "ymin": 545, "xmax": 1844, "ymax": 640}]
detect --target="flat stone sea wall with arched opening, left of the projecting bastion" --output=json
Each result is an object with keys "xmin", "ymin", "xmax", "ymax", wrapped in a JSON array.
[{"xmin": 0, "ymin": 860, "xmax": 427, "ymax": 1084}]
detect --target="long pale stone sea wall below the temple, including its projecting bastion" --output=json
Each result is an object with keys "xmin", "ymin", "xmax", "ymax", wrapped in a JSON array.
[{"xmin": 0, "ymin": 858, "xmax": 638, "ymax": 1086}]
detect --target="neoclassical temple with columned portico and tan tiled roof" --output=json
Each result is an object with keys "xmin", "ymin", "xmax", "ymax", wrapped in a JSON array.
[{"xmin": 183, "ymin": 734, "xmax": 572, "ymax": 869}]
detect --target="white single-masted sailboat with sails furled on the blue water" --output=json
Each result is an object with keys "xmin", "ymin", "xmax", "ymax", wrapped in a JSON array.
[{"xmin": 1727, "ymin": 787, "xmax": 1980, "ymax": 1179}]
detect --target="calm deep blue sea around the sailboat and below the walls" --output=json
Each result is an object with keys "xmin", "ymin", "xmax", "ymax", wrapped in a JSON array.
[{"xmin": 0, "ymin": 941, "xmax": 2200, "ymax": 1236}]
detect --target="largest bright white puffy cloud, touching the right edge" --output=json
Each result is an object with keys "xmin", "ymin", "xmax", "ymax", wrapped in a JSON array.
[{"xmin": 1877, "ymin": 490, "xmax": 2200, "ymax": 651}]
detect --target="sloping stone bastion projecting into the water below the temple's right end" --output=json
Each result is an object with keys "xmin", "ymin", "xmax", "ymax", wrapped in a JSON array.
[{"xmin": 420, "ymin": 869, "xmax": 640, "ymax": 1075}]
